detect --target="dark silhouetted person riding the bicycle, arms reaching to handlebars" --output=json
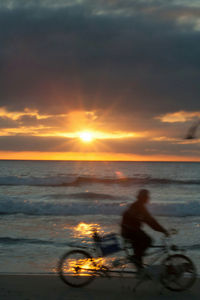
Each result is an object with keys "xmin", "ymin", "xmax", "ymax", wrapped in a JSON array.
[{"xmin": 121, "ymin": 189, "xmax": 169, "ymax": 269}]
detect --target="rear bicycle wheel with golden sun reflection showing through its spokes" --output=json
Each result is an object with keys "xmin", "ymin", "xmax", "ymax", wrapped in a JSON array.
[{"xmin": 58, "ymin": 250, "xmax": 95, "ymax": 287}]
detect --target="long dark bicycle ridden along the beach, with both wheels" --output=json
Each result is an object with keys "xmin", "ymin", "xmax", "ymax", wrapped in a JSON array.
[{"xmin": 58, "ymin": 230, "xmax": 197, "ymax": 292}]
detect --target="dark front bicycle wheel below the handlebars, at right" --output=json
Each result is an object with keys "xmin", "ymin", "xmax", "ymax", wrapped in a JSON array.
[{"xmin": 160, "ymin": 254, "xmax": 197, "ymax": 292}]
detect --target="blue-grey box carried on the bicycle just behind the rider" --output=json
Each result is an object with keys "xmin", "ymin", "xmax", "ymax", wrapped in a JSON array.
[{"xmin": 98, "ymin": 233, "xmax": 122, "ymax": 256}]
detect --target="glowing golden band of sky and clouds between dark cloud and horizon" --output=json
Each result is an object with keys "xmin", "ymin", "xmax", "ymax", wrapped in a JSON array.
[{"xmin": 0, "ymin": 107, "xmax": 200, "ymax": 161}]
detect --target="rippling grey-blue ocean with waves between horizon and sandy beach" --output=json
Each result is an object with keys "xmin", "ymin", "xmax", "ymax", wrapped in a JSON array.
[{"xmin": 0, "ymin": 161, "xmax": 200, "ymax": 273}]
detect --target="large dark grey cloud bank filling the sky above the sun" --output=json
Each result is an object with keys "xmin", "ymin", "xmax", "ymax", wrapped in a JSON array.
[{"xmin": 0, "ymin": 1, "xmax": 200, "ymax": 116}]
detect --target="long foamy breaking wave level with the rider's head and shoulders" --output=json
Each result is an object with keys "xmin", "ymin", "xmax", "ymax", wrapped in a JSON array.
[{"xmin": 0, "ymin": 198, "xmax": 200, "ymax": 217}]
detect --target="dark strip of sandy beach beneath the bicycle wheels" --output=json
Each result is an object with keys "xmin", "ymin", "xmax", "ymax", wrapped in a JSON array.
[{"xmin": 0, "ymin": 275, "xmax": 200, "ymax": 300}]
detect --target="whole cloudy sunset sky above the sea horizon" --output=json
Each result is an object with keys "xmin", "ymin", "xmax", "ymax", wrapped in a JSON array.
[{"xmin": 0, "ymin": 0, "xmax": 200, "ymax": 161}]
